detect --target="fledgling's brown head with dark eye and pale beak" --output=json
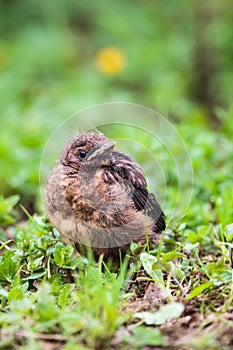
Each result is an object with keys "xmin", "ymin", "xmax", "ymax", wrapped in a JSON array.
[{"xmin": 60, "ymin": 132, "xmax": 115, "ymax": 171}]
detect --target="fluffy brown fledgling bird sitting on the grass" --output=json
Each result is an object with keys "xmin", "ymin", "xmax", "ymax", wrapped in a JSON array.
[{"xmin": 45, "ymin": 132, "xmax": 165, "ymax": 261}]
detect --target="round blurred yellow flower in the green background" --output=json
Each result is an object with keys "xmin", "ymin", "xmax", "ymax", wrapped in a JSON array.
[{"xmin": 96, "ymin": 47, "xmax": 126, "ymax": 75}]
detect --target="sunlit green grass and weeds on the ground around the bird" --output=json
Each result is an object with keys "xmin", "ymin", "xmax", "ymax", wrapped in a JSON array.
[{"xmin": 0, "ymin": 115, "xmax": 233, "ymax": 349}]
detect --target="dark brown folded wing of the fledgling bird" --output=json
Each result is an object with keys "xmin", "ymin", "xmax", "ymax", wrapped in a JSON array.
[{"xmin": 104, "ymin": 152, "xmax": 166, "ymax": 232}]
